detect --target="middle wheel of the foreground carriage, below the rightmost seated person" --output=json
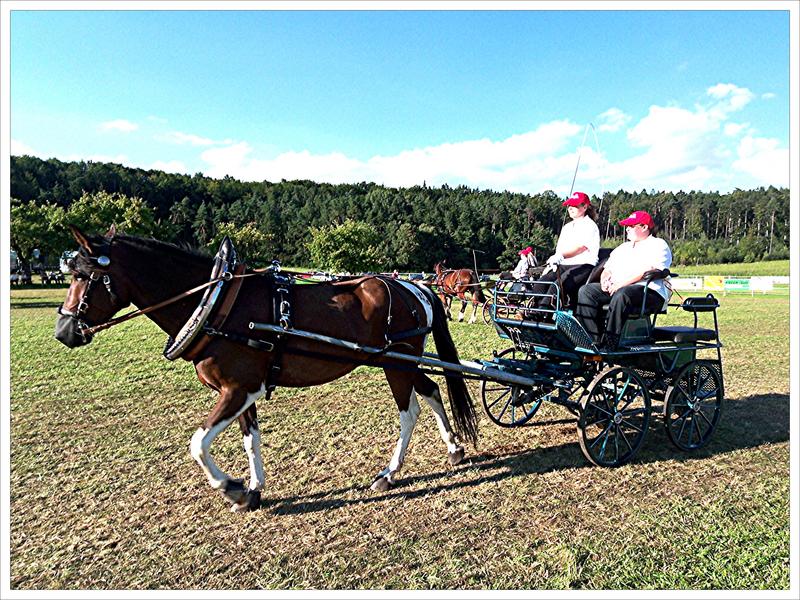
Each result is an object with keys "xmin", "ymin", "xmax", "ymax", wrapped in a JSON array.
[{"xmin": 578, "ymin": 367, "xmax": 650, "ymax": 467}]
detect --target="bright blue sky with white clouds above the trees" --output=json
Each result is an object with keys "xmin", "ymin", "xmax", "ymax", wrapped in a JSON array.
[{"xmin": 9, "ymin": 3, "xmax": 796, "ymax": 194}]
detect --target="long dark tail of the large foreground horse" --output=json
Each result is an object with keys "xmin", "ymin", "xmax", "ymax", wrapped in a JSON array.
[{"xmin": 431, "ymin": 294, "xmax": 478, "ymax": 446}]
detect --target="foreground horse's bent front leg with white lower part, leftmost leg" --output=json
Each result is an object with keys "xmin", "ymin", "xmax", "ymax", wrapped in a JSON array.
[{"xmin": 190, "ymin": 385, "xmax": 265, "ymax": 511}]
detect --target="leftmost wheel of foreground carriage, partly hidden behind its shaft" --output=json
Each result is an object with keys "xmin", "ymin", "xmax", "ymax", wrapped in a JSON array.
[{"xmin": 481, "ymin": 348, "xmax": 549, "ymax": 427}]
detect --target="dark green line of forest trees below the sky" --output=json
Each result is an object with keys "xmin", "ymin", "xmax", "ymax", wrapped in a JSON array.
[{"xmin": 10, "ymin": 156, "xmax": 789, "ymax": 271}]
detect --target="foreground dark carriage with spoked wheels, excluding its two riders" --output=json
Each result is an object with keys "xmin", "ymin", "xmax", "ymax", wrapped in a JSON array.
[{"xmin": 481, "ymin": 269, "xmax": 724, "ymax": 467}]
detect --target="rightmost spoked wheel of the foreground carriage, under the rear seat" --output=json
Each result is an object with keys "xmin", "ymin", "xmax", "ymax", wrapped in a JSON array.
[{"xmin": 664, "ymin": 360, "xmax": 723, "ymax": 450}]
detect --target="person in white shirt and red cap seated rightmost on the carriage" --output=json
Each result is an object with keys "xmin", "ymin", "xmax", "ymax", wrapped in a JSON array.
[{"xmin": 575, "ymin": 210, "xmax": 672, "ymax": 350}]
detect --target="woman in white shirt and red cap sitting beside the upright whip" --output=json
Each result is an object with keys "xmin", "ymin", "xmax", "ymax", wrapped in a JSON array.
[{"xmin": 533, "ymin": 192, "xmax": 600, "ymax": 311}]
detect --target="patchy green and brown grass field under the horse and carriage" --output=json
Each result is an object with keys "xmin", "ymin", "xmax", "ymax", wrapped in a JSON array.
[{"xmin": 10, "ymin": 289, "xmax": 790, "ymax": 590}]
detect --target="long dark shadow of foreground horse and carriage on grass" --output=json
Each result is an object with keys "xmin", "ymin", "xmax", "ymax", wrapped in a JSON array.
[{"xmin": 261, "ymin": 394, "xmax": 789, "ymax": 514}]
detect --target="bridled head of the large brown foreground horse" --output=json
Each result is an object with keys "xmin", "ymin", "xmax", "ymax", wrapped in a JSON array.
[{"xmin": 55, "ymin": 226, "xmax": 130, "ymax": 348}]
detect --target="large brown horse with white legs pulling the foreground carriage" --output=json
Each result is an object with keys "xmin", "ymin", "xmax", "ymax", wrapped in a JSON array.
[{"xmin": 55, "ymin": 226, "xmax": 477, "ymax": 512}]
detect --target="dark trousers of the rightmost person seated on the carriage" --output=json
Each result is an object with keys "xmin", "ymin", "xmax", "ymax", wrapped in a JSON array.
[{"xmin": 575, "ymin": 283, "xmax": 664, "ymax": 344}]
